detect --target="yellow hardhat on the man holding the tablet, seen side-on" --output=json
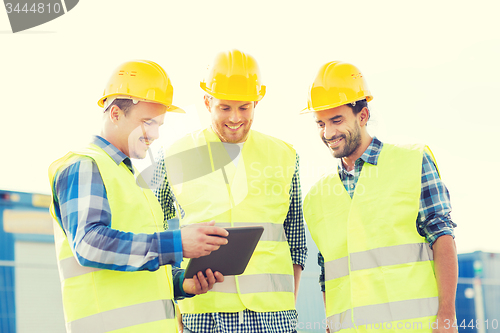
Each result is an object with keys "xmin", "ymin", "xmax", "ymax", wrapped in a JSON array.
[{"xmin": 97, "ymin": 60, "xmax": 185, "ymax": 113}]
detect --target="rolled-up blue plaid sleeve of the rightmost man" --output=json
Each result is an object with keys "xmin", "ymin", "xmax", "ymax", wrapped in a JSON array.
[{"xmin": 417, "ymin": 152, "xmax": 457, "ymax": 247}]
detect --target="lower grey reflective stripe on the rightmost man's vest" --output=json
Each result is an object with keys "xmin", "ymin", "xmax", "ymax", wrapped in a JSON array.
[{"xmin": 327, "ymin": 297, "xmax": 439, "ymax": 333}]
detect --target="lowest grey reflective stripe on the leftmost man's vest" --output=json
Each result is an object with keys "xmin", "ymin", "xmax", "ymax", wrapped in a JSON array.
[{"xmin": 67, "ymin": 299, "xmax": 175, "ymax": 333}]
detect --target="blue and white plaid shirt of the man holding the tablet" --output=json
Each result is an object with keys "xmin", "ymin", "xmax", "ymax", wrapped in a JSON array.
[{"xmin": 52, "ymin": 136, "xmax": 187, "ymax": 297}]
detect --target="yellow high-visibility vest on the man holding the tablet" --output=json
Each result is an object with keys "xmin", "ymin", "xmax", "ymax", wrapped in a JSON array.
[{"xmin": 49, "ymin": 144, "xmax": 177, "ymax": 333}]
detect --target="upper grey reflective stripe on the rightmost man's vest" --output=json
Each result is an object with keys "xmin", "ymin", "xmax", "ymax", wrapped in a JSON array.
[{"xmin": 325, "ymin": 243, "xmax": 433, "ymax": 281}]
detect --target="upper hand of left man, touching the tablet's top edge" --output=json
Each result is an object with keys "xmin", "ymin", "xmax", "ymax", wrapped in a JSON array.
[{"xmin": 181, "ymin": 221, "xmax": 229, "ymax": 258}]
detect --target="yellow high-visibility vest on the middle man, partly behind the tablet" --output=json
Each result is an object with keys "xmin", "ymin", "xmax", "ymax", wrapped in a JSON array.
[{"xmin": 165, "ymin": 129, "xmax": 296, "ymax": 313}]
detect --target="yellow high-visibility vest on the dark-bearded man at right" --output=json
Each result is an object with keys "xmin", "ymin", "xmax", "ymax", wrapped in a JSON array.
[{"xmin": 304, "ymin": 144, "xmax": 438, "ymax": 333}]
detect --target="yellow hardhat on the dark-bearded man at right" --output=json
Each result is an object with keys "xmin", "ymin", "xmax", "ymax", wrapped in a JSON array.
[{"xmin": 300, "ymin": 61, "xmax": 373, "ymax": 114}]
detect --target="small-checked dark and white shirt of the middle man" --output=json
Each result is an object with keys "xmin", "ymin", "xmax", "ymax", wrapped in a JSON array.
[{"xmin": 153, "ymin": 146, "xmax": 307, "ymax": 333}]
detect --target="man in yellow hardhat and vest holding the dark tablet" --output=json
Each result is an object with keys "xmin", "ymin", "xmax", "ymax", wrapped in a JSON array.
[{"xmin": 49, "ymin": 60, "xmax": 227, "ymax": 332}]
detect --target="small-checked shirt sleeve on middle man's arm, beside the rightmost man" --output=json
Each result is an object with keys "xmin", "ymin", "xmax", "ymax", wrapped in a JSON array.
[{"xmin": 283, "ymin": 155, "xmax": 307, "ymax": 269}]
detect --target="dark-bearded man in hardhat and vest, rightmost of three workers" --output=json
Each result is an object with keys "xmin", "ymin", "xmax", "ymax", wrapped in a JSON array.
[{"xmin": 302, "ymin": 61, "xmax": 458, "ymax": 332}]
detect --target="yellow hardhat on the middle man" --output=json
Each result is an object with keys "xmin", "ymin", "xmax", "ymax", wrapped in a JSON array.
[{"xmin": 200, "ymin": 50, "xmax": 266, "ymax": 101}]
